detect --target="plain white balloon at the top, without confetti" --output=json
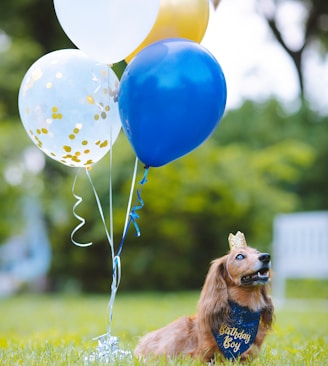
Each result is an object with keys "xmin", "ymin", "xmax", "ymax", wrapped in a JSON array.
[{"xmin": 54, "ymin": 0, "xmax": 160, "ymax": 63}]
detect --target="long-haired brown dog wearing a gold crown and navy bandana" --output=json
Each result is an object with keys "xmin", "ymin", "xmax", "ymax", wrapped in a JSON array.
[{"xmin": 134, "ymin": 231, "xmax": 274, "ymax": 364}]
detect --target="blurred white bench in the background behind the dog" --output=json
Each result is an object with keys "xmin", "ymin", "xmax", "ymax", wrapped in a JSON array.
[{"xmin": 272, "ymin": 211, "xmax": 328, "ymax": 300}]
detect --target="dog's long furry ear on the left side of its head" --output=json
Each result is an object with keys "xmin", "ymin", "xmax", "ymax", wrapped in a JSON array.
[{"xmin": 198, "ymin": 256, "xmax": 229, "ymax": 331}]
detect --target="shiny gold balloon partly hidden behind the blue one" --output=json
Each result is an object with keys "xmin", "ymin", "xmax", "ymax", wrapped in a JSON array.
[{"xmin": 125, "ymin": 0, "xmax": 209, "ymax": 63}]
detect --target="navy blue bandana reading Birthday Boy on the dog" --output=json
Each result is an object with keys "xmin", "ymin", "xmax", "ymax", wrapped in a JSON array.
[{"xmin": 212, "ymin": 301, "xmax": 261, "ymax": 360}]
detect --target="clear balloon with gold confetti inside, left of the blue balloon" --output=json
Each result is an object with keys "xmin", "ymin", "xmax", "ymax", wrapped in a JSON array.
[{"xmin": 18, "ymin": 49, "xmax": 121, "ymax": 167}]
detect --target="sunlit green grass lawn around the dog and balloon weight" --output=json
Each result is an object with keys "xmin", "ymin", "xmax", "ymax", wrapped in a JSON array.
[{"xmin": 0, "ymin": 292, "xmax": 328, "ymax": 366}]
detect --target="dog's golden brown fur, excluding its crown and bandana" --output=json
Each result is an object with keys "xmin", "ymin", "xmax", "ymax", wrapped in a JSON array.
[{"xmin": 134, "ymin": 237, "xmax": 273, "ymax": 362}]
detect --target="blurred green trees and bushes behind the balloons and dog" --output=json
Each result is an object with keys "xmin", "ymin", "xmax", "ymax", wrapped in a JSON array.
[{"xmin": 0, "ymin": 0, "xmax": 328, "ymax": 292}]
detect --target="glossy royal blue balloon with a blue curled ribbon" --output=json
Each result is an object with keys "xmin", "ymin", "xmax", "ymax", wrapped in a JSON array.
[{"xmin": 118, "ymin": 38, "xmax": 227, "ymax": 167}]
